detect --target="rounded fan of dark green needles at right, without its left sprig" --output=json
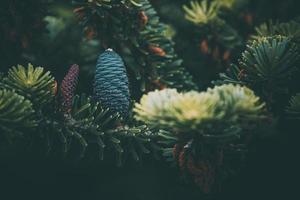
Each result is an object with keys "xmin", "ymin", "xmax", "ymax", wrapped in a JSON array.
[{"xmin": 239, "ymin": 36, "xmax": 299, "ymax": 82}]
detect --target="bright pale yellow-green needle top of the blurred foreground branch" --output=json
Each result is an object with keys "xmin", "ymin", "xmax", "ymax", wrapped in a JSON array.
[{"xmin": 134, "ymin": 84, "xmax": 264, "ymax": 138}]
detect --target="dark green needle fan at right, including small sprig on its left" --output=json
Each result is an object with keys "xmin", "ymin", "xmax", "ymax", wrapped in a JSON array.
[{"xmin": 221, "ymin": 35, "xmax": 300, "ymax": 92}]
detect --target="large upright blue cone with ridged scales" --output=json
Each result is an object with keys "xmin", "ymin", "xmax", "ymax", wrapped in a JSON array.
[{"xmin": 94, "ymin": 49, "xmax": 130, "ymax": 118}]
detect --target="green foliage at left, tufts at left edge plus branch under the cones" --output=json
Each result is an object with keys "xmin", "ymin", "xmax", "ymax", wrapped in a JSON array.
[{"xmin": 0, "ymin": 63, "xmax": 159, "ymax": 165}]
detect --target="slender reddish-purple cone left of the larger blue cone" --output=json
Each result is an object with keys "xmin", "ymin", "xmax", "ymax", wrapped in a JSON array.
[{"xmin": 61, "ymin": 64, "xmax": 79, "ymax": 113}]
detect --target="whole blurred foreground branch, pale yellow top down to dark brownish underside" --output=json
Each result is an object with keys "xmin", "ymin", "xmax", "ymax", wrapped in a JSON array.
[{"xmin": 134, "ymin": 84, "xmax": 265, "ymax": 193}]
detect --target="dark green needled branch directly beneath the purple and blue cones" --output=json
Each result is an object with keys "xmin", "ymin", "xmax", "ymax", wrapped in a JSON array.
[{"xmin": 40, "ymin": 95, "xmax": 159, "ymax": 165}]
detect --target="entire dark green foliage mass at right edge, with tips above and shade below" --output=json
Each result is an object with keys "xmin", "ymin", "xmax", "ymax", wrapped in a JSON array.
[{"xmin": 217, "ymin": 21, "xmax": 300, "ymax": 112}]
